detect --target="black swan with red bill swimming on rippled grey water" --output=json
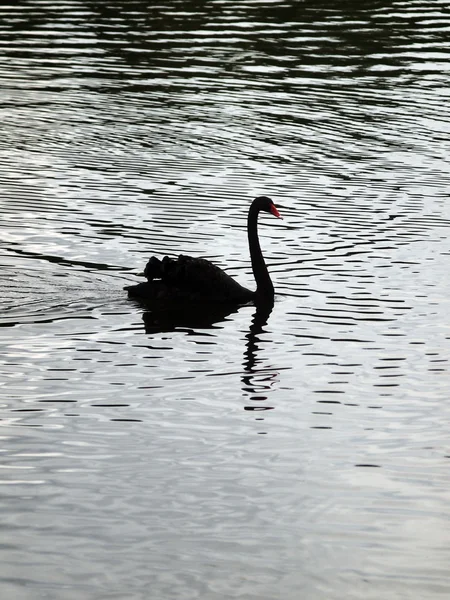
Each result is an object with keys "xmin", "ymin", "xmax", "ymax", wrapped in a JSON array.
[{"xmin": 125, "ymin": 196, "xmax": 282, "ymax": 308}]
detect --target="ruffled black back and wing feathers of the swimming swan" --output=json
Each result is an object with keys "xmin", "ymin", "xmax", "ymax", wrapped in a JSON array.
[{"xmin": 144, "ymin": 254, "xmax": 254, "ymax": 302}]
